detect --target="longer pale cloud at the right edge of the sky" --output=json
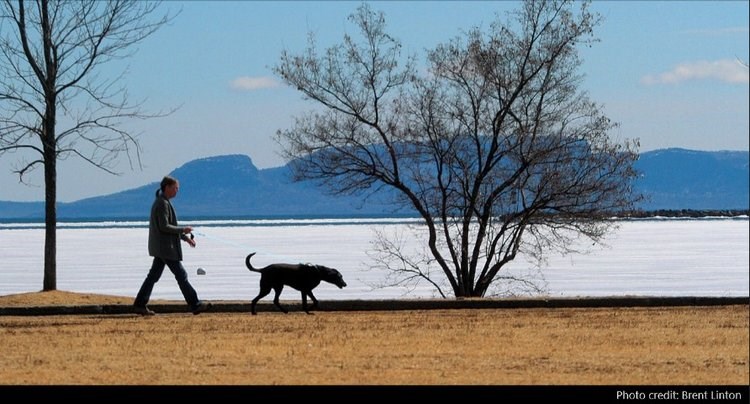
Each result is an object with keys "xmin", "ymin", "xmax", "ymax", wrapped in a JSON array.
[{"xmin": 641, "ymin": 59, "xmax": 750, "ymax": 85}]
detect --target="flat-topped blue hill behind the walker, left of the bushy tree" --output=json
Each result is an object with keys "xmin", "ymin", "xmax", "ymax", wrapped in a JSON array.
[{"xmin": 0, "ymin": 155, "xmax": 406, "ymax": 220}]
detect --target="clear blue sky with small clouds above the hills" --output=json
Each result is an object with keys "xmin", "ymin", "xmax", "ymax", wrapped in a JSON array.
[{"xmin": 0, "ymin": 1, "xmax": 750, "ymax": 202}]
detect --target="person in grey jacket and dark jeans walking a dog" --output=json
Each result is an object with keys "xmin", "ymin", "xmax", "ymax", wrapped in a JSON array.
[{"xmin": 133, "ymin": 176, "xmax": 211, "ymax": 316}]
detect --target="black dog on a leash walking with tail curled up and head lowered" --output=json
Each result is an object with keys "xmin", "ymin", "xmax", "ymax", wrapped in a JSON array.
[{"xmin": 250, "ymin": 253, "xmax": 346, "ymax": 314}]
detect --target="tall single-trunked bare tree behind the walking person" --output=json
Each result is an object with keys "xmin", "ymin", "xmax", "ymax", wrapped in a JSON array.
[{"xmin": 0, "ymin": 0, "xmax": 169, "ymax": 291}]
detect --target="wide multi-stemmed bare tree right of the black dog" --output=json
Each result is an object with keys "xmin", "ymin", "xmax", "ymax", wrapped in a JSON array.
[{"xmin": 275, "ymin": 0, "xmax": 639, "ymax": 297}]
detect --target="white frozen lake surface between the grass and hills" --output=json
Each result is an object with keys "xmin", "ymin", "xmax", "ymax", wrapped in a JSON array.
[{"xmin": 0, "ymin": 218, "xmax": 750, "ymax": 300}]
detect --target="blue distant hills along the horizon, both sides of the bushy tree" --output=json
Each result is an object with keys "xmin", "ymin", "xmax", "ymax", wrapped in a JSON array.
[{"xmin": 0, "ymin": 149, "xmax": 750, "ymax": 220}]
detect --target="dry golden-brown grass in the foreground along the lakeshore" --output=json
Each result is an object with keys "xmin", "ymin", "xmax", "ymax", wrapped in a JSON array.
[{"xmin": 0, "ymin": 292, "xmax": 750, "ymax": 385}]
